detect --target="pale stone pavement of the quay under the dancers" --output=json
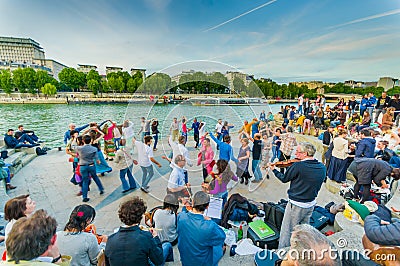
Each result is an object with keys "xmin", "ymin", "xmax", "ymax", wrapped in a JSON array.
[{"xmin": 0, "ymin": 136, "xmax": 346, "ymax": 265}]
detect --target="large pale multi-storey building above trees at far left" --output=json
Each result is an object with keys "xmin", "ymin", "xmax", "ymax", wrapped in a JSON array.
[{"xmin": 0, "ymin": 37, "xmax": 67, "ymax": 80}]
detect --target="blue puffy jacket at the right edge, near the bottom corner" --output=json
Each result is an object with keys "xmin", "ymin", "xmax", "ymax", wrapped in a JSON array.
[{"xmin": 364, "ymin": 215, "xmax": 400, "ymax": 246}]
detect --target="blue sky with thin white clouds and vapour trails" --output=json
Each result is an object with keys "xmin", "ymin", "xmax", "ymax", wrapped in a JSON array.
[{"xmin": 0, "ymin": 0, "xmax": 400, "ymax": 83}]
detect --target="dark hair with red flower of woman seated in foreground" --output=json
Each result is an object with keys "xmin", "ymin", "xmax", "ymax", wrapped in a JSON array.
[{"xmin": 64, "ymin": 204, "xmax": 96, "ymax": 232}]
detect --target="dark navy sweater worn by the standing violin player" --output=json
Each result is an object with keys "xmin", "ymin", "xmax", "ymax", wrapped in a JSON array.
[{"xmin": 273, "ymin": 159, "xmax": 326, "ymax": 202}]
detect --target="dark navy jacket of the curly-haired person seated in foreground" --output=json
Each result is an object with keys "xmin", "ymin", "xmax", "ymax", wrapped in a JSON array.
[{"xmin": 105, "ymin": 226, "xmax": 164, "ymax": 266}]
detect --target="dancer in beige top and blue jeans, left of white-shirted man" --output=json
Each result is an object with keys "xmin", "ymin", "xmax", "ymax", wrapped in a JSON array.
[{"xmin": 114, "ymin": 139, "xmax": 137, "ymax": 193}]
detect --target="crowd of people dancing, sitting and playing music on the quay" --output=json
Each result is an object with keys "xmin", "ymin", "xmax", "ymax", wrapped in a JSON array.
[{"xmin": 5, "ymin": 93, "xmax": 400, "ymax": 265}]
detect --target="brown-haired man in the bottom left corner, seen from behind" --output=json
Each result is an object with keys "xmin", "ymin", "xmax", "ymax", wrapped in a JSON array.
[{"xmin": 4, "ymin": 210, "xmax": 69, "ymax": 265}]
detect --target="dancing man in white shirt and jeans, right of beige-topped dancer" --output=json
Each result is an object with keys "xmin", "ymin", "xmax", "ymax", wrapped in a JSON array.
[{"xmin": 132, "ymin": 136, "xmax": 161, "ymax": 193}]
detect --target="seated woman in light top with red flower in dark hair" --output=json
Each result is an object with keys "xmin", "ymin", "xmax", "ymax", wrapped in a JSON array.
[{"xmin": 57, "ymin": 204, "xmax": 107, "ymax": 266}]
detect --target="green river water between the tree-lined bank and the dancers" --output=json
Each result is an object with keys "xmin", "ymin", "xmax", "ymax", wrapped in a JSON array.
[{"xmin": 0, "ymin": 103, "xmax": 281, "ymax": 147}]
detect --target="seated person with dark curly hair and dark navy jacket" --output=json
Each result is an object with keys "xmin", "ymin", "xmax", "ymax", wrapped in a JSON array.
[{"xmin": 104, "ymin": 196, "xmax": 165, "ymax": 266}]
